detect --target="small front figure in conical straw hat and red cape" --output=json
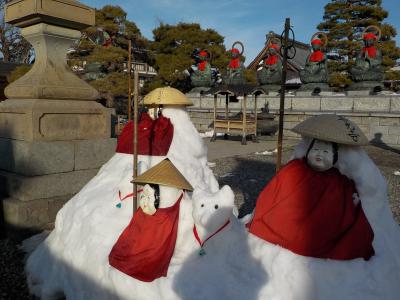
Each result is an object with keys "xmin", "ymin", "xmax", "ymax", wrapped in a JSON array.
[{"xmin": 109, "ymin": 159, "xmax": 193, "ymax": 282}]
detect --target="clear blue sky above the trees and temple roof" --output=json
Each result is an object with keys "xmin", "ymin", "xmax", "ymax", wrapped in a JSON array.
[{"xmin": 80, "ymin": 0, "xmax": 400, "ymax": 64}]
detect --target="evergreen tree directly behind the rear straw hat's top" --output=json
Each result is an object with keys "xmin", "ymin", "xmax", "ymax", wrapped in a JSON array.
[{"xmin": 146, "ymin": 23, "xmax": 229, "ymax": 92}]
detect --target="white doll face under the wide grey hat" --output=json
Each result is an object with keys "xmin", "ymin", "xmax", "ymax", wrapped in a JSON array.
[{"xmin": 307, "ymin": 140, "xmax": 333, "ymax": 171}]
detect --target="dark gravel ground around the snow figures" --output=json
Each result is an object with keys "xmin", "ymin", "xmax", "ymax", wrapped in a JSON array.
[{"xmin": 0, "ymin": 146, "xmax": 400, "ymax": 300}]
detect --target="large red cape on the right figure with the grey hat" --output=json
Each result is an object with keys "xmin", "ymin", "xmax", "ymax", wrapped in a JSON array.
[{"xmin": 249, "ymin": 159, "xmax": 374, "ymax": 260}]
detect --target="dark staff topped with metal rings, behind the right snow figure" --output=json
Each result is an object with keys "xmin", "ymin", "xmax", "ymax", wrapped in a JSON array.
[{"xmin": 276, "ymin": 18, "xmax": 290, "ymax": 173}]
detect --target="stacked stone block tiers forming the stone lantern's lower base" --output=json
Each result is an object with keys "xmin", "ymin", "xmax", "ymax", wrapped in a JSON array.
[{"xmin": 0, "ymin": 138, "xmax": 116, "ymax": 234}]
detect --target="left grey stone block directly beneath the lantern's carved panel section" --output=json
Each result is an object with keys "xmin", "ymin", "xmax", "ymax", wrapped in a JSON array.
[{"xmin": 0, "ymin": 138, "xmax": 74, "ymax": 176}]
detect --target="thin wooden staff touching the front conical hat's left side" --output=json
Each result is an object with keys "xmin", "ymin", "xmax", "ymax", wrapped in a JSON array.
[{"xmin": 133, "ymin": 70, "xmax": 140, "ymax": 212}]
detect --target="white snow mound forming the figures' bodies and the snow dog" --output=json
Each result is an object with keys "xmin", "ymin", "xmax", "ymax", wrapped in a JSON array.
[{"xmin": 26, "ymin": 109, "xmax": 400, "ymax": 300}]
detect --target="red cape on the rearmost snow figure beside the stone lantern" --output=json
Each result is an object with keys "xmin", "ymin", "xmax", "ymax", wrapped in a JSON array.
[{"xmin": 116, "ymin": 113, "xmax": 174, "ymax": 156}]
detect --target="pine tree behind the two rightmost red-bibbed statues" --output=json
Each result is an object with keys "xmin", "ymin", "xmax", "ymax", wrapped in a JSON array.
[{"xmin": 317, "ymin": 0, "xmax": 400, "ymax": 86}]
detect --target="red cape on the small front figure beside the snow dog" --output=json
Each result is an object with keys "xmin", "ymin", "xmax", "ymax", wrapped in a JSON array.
[{"xmin": 108, "ymin": 194, "xmax": 183, "ymax": 282}]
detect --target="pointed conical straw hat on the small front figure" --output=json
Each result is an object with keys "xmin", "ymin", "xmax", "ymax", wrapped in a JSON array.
[{"xmin": 133, "ymin": 158, "xmax": 193, "ymax": 191}]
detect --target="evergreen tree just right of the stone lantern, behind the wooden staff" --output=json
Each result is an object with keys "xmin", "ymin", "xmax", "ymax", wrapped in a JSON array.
[{"xmin": 69, "ymin": 5, "xmax": 151, "ymax": 113}]
